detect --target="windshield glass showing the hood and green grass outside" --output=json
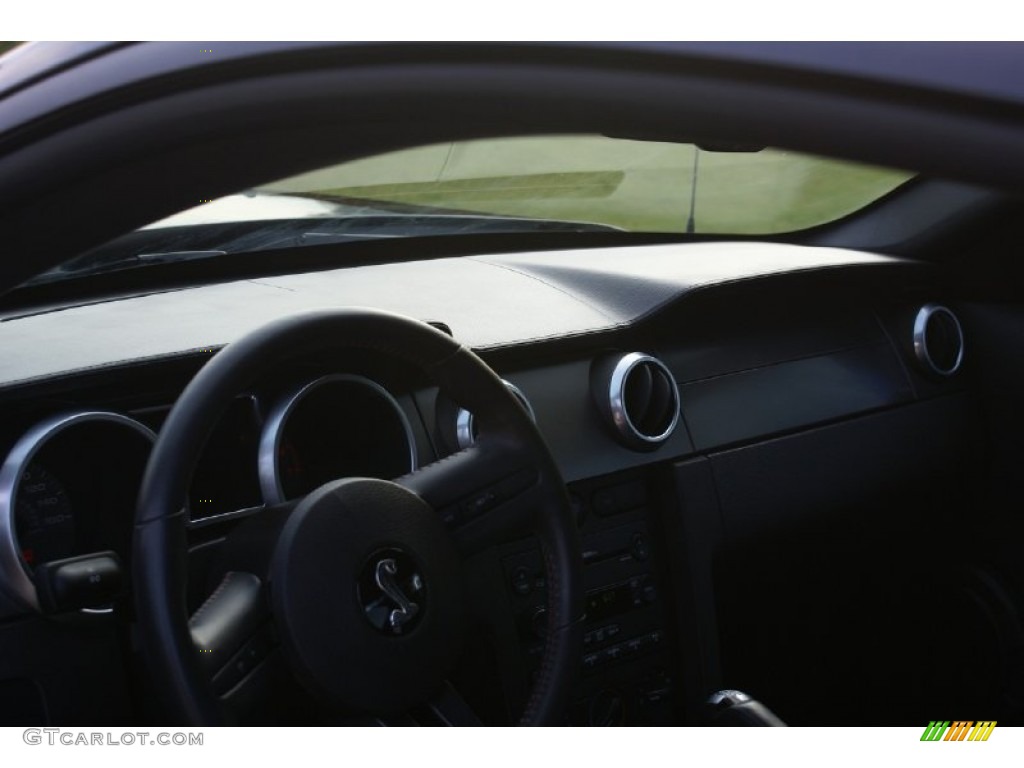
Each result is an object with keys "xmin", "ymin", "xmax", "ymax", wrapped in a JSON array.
[{"xmin": 33, "ymin": 135, "xmax": 912, "ymax": 282}]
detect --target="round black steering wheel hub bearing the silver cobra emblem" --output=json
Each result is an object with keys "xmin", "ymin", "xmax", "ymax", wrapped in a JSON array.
[{"xmin": 271, "ymin": 479, "xmax": 465, "ymax": 713}]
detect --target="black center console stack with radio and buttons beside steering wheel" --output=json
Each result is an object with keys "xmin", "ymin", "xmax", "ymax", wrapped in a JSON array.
[{"xmin": 502, "ymin": 475, "xmax": 678, "ymax": 725}]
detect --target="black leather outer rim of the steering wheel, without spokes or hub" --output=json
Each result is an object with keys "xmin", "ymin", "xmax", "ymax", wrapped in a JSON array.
[{"xmin": 132, "ymin": 309, "xmax": 582, "ymax": 725}]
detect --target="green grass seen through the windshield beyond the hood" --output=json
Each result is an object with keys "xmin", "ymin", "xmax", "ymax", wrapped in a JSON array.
[{"xmin": 264, "ymin": 136, "xmax": 912, "ymax": 234}]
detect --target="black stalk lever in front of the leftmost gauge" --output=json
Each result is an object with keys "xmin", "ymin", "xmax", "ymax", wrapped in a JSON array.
[{"xmin": 36, "ymin": 552, "xmax": 124, "ymax": 613}]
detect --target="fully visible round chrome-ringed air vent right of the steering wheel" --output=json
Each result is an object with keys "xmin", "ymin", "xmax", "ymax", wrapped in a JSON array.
[{"xmin": 591, "ymin": 352, "xmax": 679, "ymax": 451}]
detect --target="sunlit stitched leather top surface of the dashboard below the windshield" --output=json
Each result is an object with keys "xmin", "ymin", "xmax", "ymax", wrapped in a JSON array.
[{"xmin": 0, "ymin": 243, "xmax": 901, "ymax": 386}]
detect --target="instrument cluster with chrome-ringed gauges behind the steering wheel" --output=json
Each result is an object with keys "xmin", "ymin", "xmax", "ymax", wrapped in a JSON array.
[{"xmin": 0, "ymin": 373, "xmax": 418, "ymax": 612}]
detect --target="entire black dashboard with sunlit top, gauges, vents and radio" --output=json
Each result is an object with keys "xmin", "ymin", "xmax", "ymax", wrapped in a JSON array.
[{"xmin": 0, "ymin": 243, "xmax": 1002, "ymax": 725}]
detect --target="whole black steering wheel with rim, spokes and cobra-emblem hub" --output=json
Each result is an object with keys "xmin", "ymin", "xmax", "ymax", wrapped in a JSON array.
[{"xmin": 132, "ymin": 309, "xmax": 582, "ymax": 725}]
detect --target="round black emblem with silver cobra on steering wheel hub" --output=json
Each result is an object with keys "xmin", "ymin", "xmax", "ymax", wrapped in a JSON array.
[{"xmin": 358, "ymin": 549, "xmax": 427, "ymax": 635}]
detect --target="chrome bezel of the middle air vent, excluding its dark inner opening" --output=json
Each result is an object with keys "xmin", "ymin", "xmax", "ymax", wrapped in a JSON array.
[{"xmin": 593, "ymin": 352, "xmax": 682, "ymax": 451}]
